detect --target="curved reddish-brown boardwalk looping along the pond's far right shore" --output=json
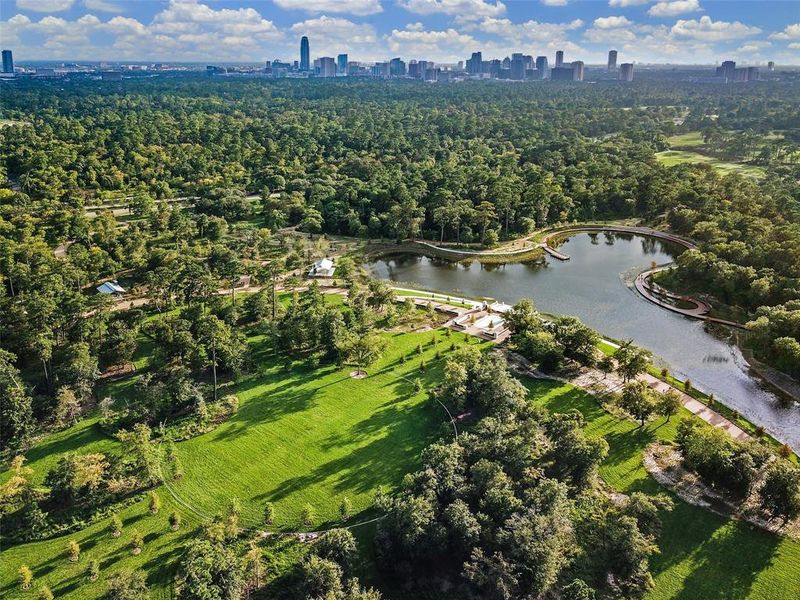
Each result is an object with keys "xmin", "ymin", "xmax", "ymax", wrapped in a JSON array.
[{"xmin": 541, "ymin": 225, "xmax": 745, "ymax": 329}]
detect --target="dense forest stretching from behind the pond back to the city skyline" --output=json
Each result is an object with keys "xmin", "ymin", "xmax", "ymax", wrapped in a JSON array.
[{"xmin": 0, "ymin": 77, "xmax": 800, "ymax": 375}]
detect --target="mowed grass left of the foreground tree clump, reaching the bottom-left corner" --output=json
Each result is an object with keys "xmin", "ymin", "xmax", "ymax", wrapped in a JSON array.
[{"xmin": 0, "ymin": 330, "xmax": 472, "ymax": 600}]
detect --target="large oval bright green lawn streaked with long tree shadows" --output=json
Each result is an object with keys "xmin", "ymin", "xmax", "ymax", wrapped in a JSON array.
[{"xmin": 169, "ymin": 333, "xmax": 456, "ymax": 529}]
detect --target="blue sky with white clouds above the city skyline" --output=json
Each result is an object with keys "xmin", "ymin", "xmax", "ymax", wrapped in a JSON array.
[{"xmin": 0, "ymin": 0, "xmax": 800, "ymax": 64}]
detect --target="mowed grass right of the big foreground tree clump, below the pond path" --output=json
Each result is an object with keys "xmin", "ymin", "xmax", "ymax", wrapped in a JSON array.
[{"xmin": 525, "ymin": 380, "xmax": 800, "ymax": 600}]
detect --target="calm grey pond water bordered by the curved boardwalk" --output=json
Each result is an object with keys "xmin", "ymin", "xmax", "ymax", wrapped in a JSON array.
[{"xmin": 371, "ymin": 233, "xmax": 800, "ymax": 449}]
